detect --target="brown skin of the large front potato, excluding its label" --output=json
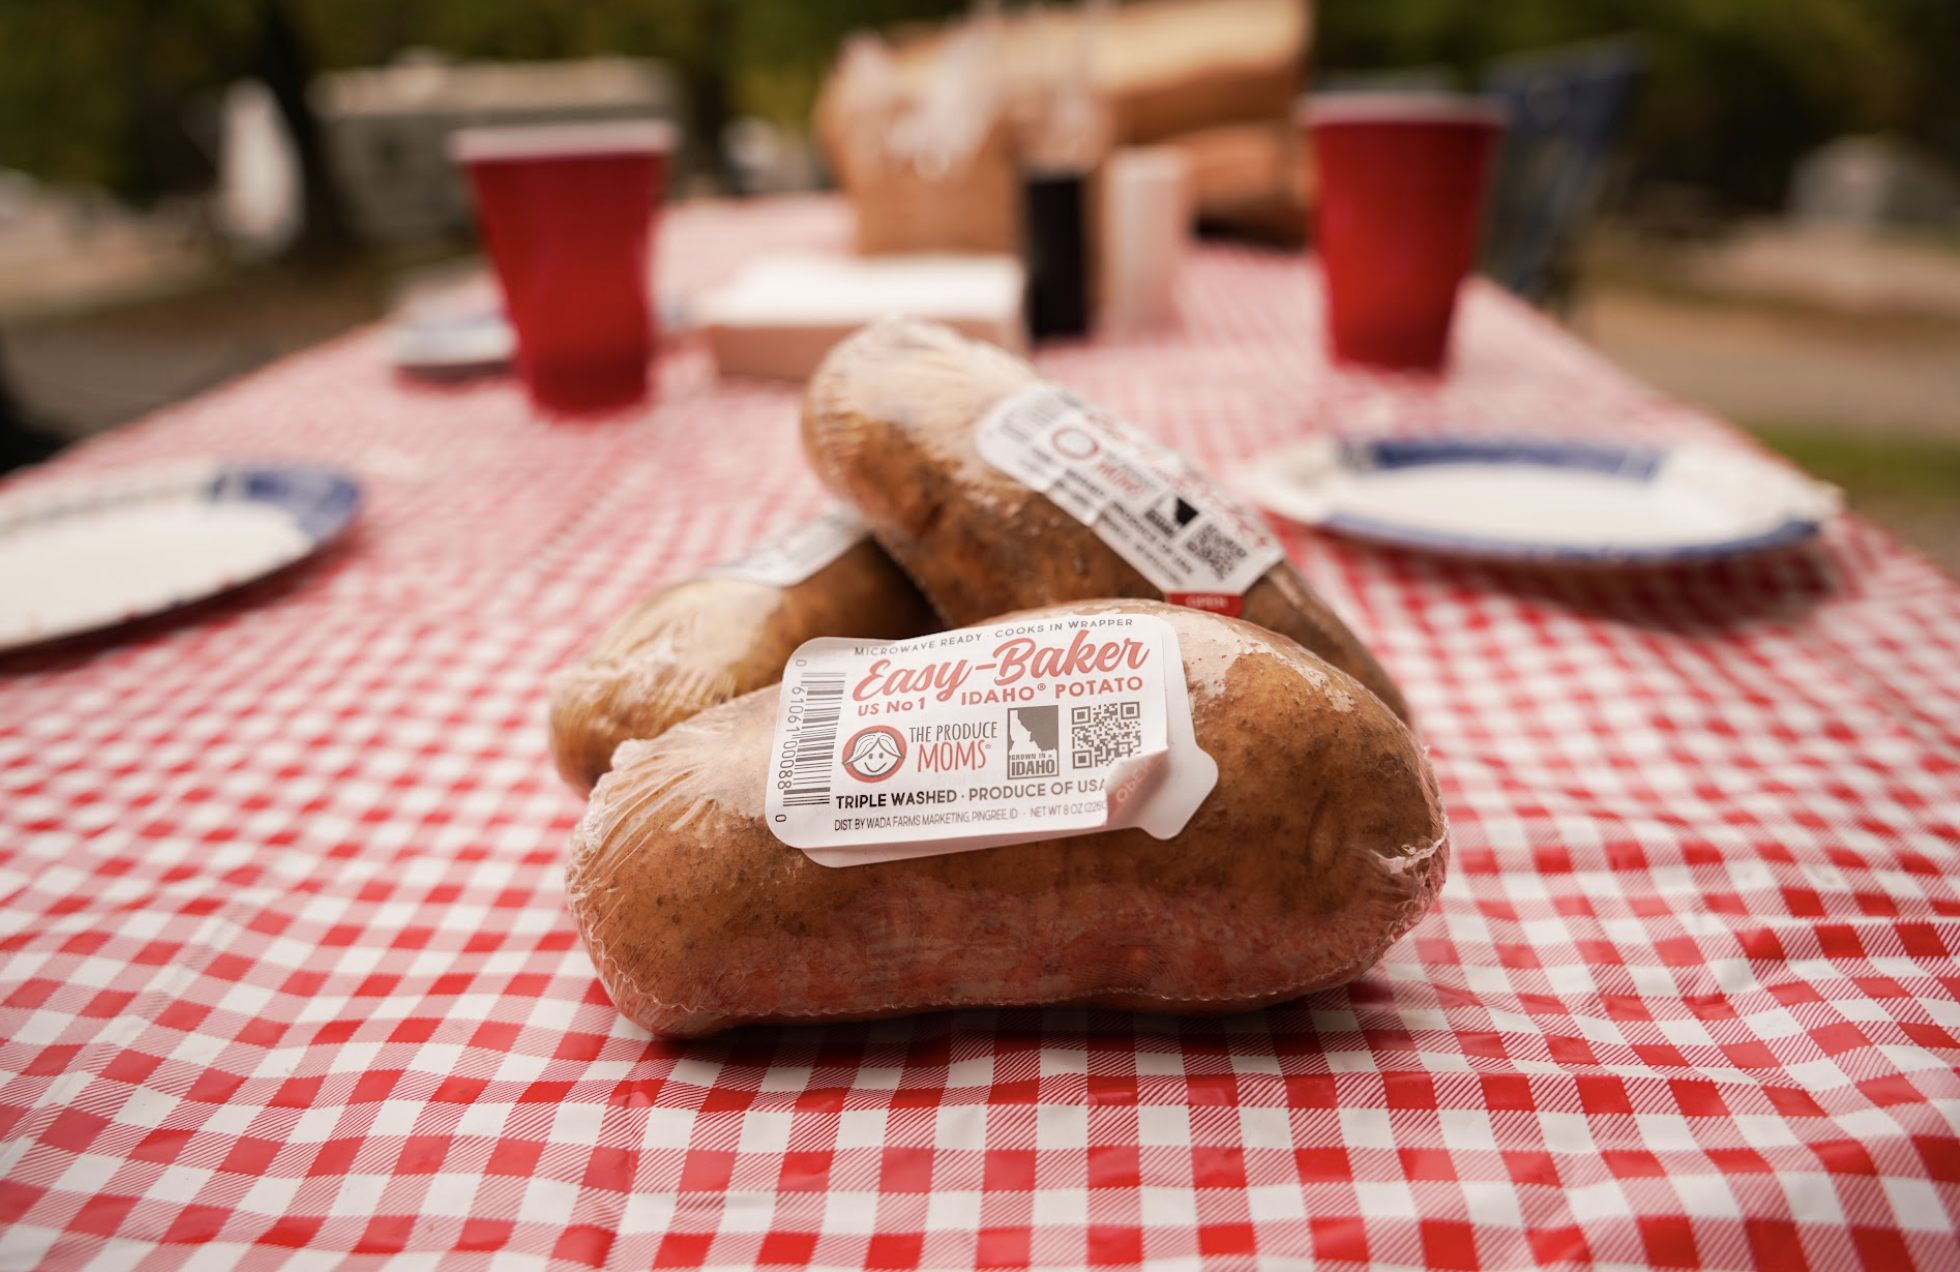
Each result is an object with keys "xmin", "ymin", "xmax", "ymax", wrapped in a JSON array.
[{"xmin": 566, "ymin": 602, "xmax": 1448, "ymax": 1037}]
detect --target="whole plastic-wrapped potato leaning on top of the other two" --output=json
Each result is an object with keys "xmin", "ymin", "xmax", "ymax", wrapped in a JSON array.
[{"xmin": 804, "ymin": 319, "xmax": 1409, "ymax": 719}]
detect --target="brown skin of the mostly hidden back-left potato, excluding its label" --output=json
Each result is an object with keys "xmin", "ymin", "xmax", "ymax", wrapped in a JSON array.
[{"xmin": 549, "ymin": 539, "xmax": 941, "ymax": 794}]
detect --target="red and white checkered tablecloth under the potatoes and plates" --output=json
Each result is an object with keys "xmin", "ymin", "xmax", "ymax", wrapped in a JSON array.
[{"xmin": 0, "ymin": 202, "xmax": 1960, "ymax": 1272}]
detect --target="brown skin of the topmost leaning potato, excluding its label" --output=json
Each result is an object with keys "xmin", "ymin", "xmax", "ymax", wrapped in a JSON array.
[{"xmin": 804, "ymin": 319, "xmax": 1411, "ymax": 721}]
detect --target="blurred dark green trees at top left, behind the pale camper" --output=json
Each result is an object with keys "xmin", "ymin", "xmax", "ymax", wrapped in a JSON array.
[{"xmin": 0, "ymin": 0, "xmax": 964, "ymax": 198}]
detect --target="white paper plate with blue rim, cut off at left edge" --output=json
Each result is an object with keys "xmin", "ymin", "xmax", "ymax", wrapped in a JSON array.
[{"xmin": 0, "ymin": 465, "xmax": 361, "ymax": 651}]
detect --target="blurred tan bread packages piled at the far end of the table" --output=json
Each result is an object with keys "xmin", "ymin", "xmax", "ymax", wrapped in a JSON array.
[{"xmin": 815, "ymin": 0, "xmax": 1311, "ymax": 253}]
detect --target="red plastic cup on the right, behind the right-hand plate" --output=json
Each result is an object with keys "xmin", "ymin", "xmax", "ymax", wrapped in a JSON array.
[{"xmin": 1296, "ymin": 92, "xmax": 1505, "ymax": 370}]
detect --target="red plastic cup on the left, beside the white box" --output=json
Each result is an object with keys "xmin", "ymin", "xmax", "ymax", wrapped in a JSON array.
[{"xmin": 451, "ymin": 120, "xmax": 674, "ymax": 416}]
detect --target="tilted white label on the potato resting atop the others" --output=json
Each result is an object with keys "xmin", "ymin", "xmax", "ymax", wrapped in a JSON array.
[{"xmin": 978, "ymin": 384, "xmax": 1286, "ymax": 615}]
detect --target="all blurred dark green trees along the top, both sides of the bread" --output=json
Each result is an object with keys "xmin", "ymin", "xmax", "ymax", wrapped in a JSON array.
[{"xmin": 0, "ymin": 0, "xmax": 1960, "ymax": 208}]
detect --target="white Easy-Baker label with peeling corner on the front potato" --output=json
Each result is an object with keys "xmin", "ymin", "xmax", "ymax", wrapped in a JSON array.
[{"xmin": 766, "ymin": 613, "xmax": 1217, "ymax": 866}]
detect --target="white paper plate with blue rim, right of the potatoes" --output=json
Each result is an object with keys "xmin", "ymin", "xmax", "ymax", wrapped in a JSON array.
[{"xmin": 1233, "ymin": 437, "xmax": 1842, "ymax": 566}]
